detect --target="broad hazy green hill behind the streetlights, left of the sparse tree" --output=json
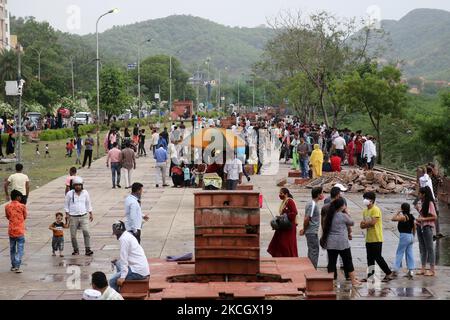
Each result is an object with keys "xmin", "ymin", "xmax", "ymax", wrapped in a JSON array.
[{"xmin": 78, "ymin": 15, "xmax": 273, "ymax": 74}]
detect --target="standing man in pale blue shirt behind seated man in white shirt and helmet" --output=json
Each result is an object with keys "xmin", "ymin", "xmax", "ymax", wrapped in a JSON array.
[{"xmin": 125, "ymin": 182, "xmax": 149, "ymax": 244}]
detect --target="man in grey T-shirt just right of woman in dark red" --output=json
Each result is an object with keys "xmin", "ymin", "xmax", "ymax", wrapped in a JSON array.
[{"xmin": 300, "ymin": 187, "xmax": 325, "ymax": 269}]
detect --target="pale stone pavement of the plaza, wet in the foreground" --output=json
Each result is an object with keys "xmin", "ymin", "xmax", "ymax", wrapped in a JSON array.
[{"xmin": 0, "ymin": 145, "xmax": 450, "ymax": 299}]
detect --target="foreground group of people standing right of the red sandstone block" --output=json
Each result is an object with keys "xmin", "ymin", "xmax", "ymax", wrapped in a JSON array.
[{"xmin": 268, "ymin": 185, "xmax": 438, "ymax": 286}]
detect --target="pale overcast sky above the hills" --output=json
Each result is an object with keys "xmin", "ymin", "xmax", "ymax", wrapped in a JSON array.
[{"xmin": 8, "ymin": 0, "xmax": 450, "ymax": 34}]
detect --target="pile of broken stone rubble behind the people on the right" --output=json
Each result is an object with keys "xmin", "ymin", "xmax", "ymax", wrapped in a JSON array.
[{"xmin": 306, "ymin": 169, "xmax": 416, "ymax": 194}]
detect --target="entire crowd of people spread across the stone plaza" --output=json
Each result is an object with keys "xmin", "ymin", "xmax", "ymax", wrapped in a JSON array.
[{"xmin": 0, "ymin": 114, "xmax": 443, "ymax": 300}]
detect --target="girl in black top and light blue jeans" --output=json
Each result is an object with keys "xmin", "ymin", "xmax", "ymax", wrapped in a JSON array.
[{"xmin": 392, "ymin": 203, "xmax": 416, "ymax": 280}]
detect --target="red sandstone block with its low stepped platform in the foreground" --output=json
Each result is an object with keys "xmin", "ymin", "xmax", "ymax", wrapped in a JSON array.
[{"xmin": 121, "ymin": 191, "xmax": 336, "ymax": 300}]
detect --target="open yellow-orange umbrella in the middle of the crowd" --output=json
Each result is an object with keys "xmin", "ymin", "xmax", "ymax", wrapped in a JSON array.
[{"xmin": 188, "ymin": 128, "xmax": 245, "ymax": 150}]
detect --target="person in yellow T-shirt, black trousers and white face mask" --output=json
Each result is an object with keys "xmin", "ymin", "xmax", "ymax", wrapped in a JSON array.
[{"xmin": 360, "ymin": 192, "xmax": 394, "ymax": 282}]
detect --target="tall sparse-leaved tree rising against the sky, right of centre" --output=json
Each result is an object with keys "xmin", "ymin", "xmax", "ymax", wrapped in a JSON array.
[{"xmin": 256, "ymin": 12, "xmax": 371, "ymax": 126}]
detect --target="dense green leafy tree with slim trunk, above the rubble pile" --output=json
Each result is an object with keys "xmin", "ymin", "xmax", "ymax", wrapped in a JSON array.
[{"xmin": 335, "ymin": 63, "xmax": 407, "ymax": 164}]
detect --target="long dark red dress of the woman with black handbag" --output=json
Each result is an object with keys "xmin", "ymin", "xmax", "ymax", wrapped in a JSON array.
[{"xmin": 267, "ymin": 199, "xmax": 298, "ymax": 258}]
